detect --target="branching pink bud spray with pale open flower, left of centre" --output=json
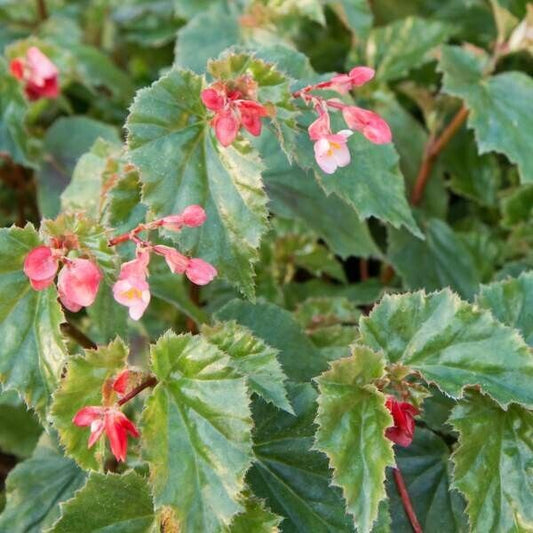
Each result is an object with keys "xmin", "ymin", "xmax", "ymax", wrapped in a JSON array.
[{"xmin": 109, "ymin": 205, "xmax": 217, "ymax": 320}]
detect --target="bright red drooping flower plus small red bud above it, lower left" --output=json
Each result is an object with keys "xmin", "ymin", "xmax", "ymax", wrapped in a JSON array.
[{"xmin": 72, "ymin": 370, "xmax": 142, "ymax": 461}]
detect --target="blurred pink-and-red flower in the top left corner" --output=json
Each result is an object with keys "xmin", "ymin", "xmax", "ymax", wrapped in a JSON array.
[{"xmin": 9, "ymin": 46, "xmax": 59, "ymax": 100}]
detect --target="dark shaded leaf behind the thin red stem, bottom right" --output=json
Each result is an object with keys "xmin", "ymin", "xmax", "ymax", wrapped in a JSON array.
[{"xmin": 388, "ymin": 427, "xmax": 468, "ymax": 533}]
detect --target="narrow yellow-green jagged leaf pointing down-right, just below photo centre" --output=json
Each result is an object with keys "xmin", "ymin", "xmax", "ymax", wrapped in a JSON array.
[{"xmin": 201, "ymin": 321, "xmax": 293, "ymax": 413}]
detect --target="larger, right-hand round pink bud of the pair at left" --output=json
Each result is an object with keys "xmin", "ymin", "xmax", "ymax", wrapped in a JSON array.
[{"xmin": 57, "ymin": 258, "xmax": 103, "ymax": 312}]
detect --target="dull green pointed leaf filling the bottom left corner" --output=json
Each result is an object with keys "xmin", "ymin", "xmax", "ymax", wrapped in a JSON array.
[{"xmin": 0, "ymin": 434, "xmax": 85, "ymax": 533}]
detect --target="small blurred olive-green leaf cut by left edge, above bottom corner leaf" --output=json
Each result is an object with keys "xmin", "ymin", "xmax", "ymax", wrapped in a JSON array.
[{"xmin": 0, "ymin": 390, "xmax": 43, "ymax": 457}]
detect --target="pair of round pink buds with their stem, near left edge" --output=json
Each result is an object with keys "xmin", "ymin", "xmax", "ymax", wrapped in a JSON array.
[{"xmin": 24, "ymin": 239, "xmax": 103, "ymax": 312}]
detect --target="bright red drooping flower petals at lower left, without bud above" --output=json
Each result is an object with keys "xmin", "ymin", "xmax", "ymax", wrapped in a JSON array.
[{"xmin": 72, "ymin": 406, "xmax": 140, "ymax": 461}]
